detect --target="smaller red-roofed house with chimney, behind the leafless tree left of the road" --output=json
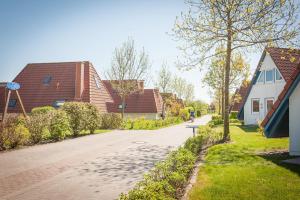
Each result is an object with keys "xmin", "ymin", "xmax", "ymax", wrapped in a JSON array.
[{"xmin": 103, "ymin": 80, "xmax": 163, "ymax": 119}]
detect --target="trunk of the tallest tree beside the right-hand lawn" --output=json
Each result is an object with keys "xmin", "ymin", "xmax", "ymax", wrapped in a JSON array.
[{"xmin": 223, "ymin": 18, "xmax": 232, "ymax": 141}]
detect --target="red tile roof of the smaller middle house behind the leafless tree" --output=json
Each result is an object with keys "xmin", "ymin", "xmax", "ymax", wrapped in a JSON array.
[{"xmin": 102, "ymin": 80, "xmax": 162, "ymax": 113}]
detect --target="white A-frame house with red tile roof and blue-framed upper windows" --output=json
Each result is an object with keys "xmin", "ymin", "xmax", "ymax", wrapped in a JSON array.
[{"xmin": 238, "ymin": 47, "xmax": 300, "ymax": 125}]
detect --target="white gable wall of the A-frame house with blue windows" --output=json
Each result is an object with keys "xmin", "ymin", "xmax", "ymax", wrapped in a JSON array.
[{"xmin": 244, "ymin": 53, "xmax": 285, "ymax": 125}]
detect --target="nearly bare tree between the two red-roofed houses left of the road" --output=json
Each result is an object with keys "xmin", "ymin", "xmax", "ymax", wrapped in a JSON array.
[{"xmin": 106, "ymin": 39, "xmax": 151, "ymax": 118}]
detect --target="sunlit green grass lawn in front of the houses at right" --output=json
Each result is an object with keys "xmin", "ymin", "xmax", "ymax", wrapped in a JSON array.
[{"xmin": 189, "ymin": 125, "xmax": 300, "ymax": 200}]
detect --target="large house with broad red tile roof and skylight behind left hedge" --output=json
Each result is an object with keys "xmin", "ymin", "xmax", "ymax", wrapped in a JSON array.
[{"xmin": 0, "ymin": 61, "xmax": 113, "ymax": 113}]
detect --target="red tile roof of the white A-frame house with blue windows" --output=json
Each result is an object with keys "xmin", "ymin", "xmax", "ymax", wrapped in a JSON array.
[{"xmin": 266, "ymin": 47, "xmax": 300, "ymax": 81}]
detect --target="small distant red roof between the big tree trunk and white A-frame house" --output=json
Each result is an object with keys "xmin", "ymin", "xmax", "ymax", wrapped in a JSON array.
[{"xmin": 231, "ymin": 81, "xmax": 250, "ymax": 111}]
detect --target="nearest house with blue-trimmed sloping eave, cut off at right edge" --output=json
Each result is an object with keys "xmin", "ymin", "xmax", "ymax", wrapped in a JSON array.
[{"xmin": 262, "ymin": 64, "xmax": 300, "ymax": 156}]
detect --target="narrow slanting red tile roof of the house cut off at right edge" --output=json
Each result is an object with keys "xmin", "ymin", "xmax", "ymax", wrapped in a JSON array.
[{"xmin": 261, "ymin": 63, "xmax": 300, "ymax": 127}]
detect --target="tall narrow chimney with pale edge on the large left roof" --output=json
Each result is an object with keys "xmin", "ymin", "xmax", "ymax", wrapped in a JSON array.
[{"xmin": 75, "ymin": 62, "xmax": 84, "ymax": 101}]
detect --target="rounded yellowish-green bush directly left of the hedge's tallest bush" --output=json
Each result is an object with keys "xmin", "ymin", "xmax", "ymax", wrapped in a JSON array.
[{"xmin": 49, "ymin": 110, "xmax": 71, "ymax": 141}]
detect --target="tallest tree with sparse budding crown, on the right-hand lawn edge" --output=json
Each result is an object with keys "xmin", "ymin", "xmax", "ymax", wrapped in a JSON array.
[{"xmin": 173, "ymin": 0, "xmax": 300, "ymax": 140}]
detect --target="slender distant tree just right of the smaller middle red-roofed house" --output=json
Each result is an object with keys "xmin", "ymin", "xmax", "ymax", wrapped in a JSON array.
[{"xmin": 155, "ymin": 63, "xmax": 172, "ymax": 119}]
